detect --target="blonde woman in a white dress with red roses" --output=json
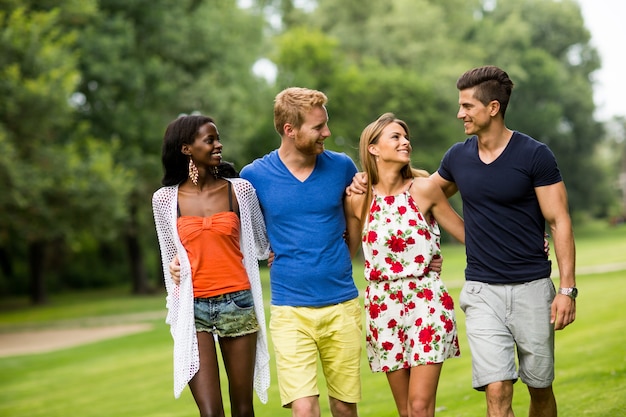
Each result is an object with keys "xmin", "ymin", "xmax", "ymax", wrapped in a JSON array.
[{"xmin": 345, "ymin": 113, "xmax": 465, "ymax": 416}]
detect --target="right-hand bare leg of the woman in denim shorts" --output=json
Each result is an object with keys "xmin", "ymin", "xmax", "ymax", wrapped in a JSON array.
[{"xmin": 219, "ymin": 333, "xmax": 257, "ymax": 417}]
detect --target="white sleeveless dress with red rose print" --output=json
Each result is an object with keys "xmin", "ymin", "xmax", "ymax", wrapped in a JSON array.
[{"xmin": 363, "ymin": 182, "xmax": 460, "ymax": 372}]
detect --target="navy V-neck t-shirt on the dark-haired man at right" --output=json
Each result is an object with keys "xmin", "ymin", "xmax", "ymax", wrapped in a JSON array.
[{"xmin": 438, "ymin": 132, "xmax": 562, "ymax": 284}]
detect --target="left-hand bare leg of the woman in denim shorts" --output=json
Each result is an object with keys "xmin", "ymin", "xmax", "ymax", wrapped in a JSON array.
[{"xmin": 189, "ymin": 332, "xmax": 224, "ymax": 417}]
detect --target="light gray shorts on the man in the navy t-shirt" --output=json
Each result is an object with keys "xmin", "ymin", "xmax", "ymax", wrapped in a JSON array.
[{"xmin": 459, "ymin": 278, "xmax": 556, "ymax": 391}]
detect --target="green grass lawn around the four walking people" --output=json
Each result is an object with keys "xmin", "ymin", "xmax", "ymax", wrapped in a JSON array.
[{"xmin": 0, "ymin": 225, "xmax": 626, "ymax": 417}]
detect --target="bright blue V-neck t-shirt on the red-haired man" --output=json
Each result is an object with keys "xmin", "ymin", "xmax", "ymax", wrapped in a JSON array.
[{"xmin": 241, "ymin": 150, "xmax": 358, "ymax": 307}]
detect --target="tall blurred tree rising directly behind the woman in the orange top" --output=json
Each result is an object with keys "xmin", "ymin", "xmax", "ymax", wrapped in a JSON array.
[{"xmin": 72, "ymin": 0, "xmax": 270, "ymax": 293}]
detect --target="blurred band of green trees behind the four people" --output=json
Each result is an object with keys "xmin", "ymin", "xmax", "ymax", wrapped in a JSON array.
[{"xmin": 0, "ymin": 0, "xmax": 626, "ymax": 304}]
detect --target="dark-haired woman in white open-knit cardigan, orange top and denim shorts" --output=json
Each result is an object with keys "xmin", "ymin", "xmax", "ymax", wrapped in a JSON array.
[{"xmin": 153, "ymin": 116, "xmax": 269, "ymax": 416}]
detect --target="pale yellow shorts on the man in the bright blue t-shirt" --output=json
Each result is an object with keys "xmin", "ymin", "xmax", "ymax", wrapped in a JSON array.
[{"xmin": 270, "ymin": 298, "xmax": 362, "ymax": 407}]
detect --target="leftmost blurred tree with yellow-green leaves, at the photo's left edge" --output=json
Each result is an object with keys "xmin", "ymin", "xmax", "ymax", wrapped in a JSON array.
[{"xmin": 0, "ymin": 3, "xmax": 129, "ymax": 303}]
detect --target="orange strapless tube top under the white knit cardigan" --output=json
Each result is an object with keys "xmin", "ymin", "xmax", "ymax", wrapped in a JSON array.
[{"xmin": 177, "ymin": 211, "xmax": 250, "ymax": 298}]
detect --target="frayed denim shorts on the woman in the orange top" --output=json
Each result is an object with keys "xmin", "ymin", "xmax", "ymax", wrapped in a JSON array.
[{"xmin": 193, "ymin": 290, "xmax": 259, "ymax": 337}]
